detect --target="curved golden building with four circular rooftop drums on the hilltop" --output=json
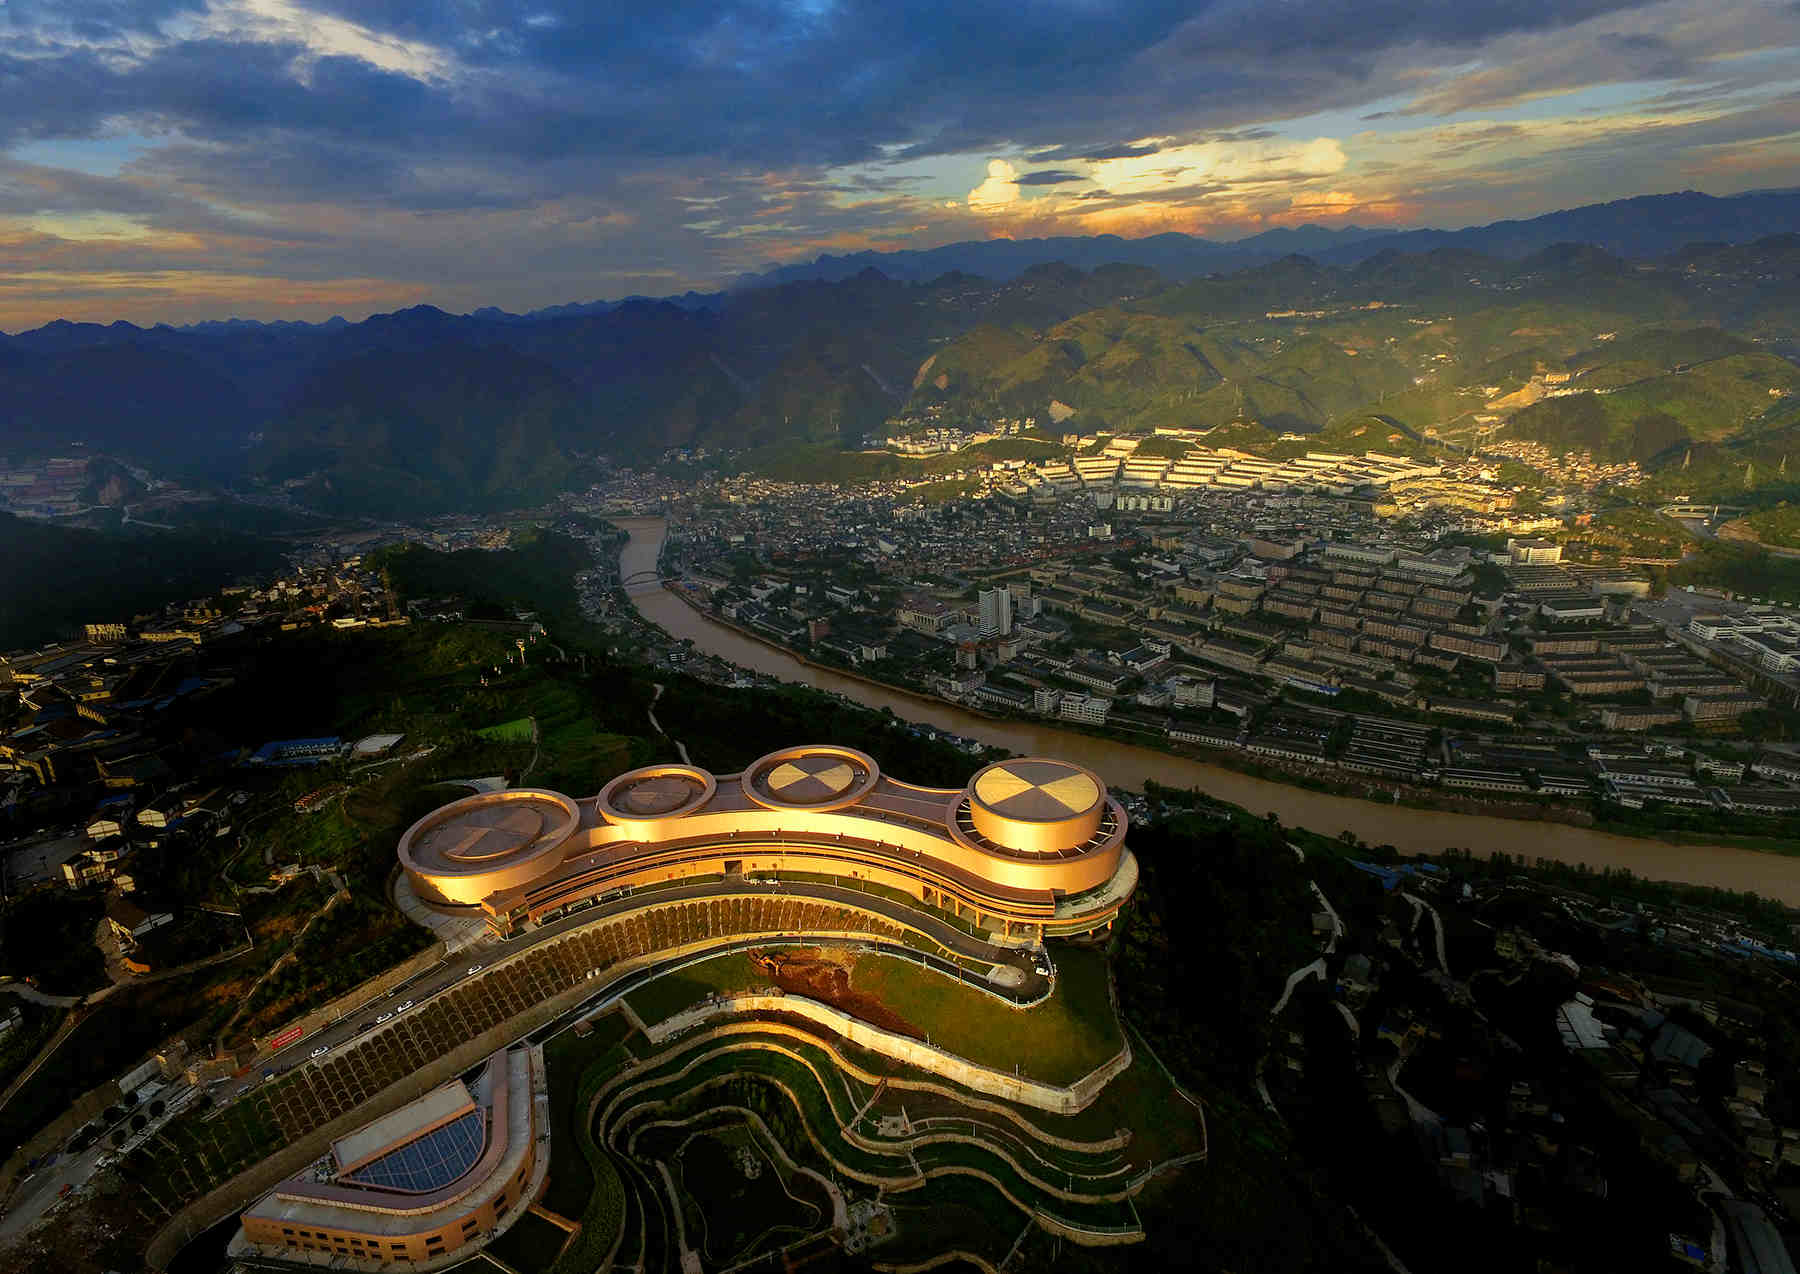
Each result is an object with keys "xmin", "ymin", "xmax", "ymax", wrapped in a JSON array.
[{"xmin": 400, "ymin": 743, "xmax": 1138, "ymax": 938}]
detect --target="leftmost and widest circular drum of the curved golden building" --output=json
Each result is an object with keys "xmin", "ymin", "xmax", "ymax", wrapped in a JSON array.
[{"xmin": 400, "ymin": 788, "xmax": 581, "ymax": 905}]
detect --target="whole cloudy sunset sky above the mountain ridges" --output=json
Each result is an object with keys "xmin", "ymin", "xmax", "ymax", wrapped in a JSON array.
[{"xmin": 0, "ymin": 0, "xmax": 1800, "ymax": 331}]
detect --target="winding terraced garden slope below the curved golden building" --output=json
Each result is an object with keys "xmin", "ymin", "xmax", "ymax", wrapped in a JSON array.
[{"xmin": 545, "ymin": 1000, "xmax": 1204, "ymax": 1270}]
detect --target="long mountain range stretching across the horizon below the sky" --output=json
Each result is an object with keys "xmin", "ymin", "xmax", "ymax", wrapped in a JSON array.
[{"xmin": 0, "ymin": 193, "xmax": 1800, "ymax": 516}]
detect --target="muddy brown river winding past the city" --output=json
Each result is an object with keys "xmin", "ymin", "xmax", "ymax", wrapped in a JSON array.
[{"xmin": 617, "ymin": 518, "xmax": 1800, "ymax": 907}]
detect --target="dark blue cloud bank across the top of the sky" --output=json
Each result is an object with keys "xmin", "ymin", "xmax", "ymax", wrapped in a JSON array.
[{"xmin": 0, "ymin": 0, "xmax": 1684, "ymax": 179}]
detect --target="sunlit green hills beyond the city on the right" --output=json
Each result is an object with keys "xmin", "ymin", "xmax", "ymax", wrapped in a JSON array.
[{"xmin": 905, "ymin": 247, "xmax": 1800, "ymax": 464}]
